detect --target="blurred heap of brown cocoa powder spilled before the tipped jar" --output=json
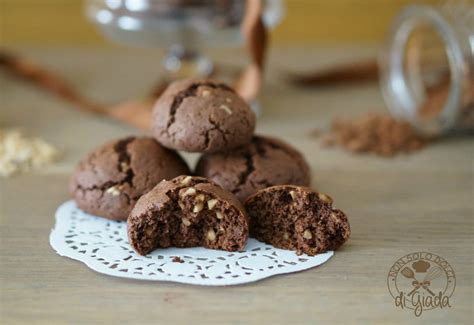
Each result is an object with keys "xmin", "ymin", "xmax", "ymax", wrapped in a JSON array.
[{"xmin": 321, "ymin": 112, "xmax": 430, "ymax": 157}]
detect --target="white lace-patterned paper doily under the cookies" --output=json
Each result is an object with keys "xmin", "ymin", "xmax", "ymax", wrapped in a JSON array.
[{"xmin": 49, "ymin": 201, "xmax": 334, "ymax": 286}]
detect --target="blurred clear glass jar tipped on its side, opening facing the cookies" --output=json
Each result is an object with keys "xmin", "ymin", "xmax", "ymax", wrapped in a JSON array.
[{"xmin": 379, "ymin": 1, "xmax": 474, "ymax": 135}]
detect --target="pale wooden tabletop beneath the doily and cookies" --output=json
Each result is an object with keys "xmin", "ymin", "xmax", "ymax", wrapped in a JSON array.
[{"xmin": 0, "ymin": 45, "xmax": 474, "ymax": 324}]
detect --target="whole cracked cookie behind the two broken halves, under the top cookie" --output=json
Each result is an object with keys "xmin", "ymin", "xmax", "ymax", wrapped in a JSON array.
[{"xmin": 196, "ymin": 136, "xmax": 311, "ymax": 202}]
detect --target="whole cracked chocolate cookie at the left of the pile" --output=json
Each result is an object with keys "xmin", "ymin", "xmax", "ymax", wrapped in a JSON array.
[{"xmin": 70, "ymin": 137, "xmax": 189, "ymax": 220}]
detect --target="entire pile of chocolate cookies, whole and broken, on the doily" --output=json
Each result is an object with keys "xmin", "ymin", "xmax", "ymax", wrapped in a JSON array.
[{"xmin": 71, "ymin": 80, "xmax": 350, "ymax": 255}]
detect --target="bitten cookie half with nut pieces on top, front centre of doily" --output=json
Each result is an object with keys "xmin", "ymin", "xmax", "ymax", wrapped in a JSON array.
[{"xmin": 128, "ymin": 176, "xmax": 249, "ymax": 255}]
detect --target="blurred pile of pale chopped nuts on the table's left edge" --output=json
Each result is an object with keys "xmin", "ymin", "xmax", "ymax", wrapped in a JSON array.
[{"xmin": 0, "ymin": 129, "xmax": 59, "ymax": 177}]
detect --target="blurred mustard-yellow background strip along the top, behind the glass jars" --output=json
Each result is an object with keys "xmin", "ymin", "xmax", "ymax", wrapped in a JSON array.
[{"xmin": 0, "ymin": 0, "xmax": 442, "ymax": 45}]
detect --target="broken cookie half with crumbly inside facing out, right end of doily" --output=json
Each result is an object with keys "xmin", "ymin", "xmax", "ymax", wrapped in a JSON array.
[{"xmin": 245, "ymin": 185, "xmax": 350, "ymax": 255}]
